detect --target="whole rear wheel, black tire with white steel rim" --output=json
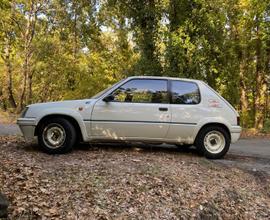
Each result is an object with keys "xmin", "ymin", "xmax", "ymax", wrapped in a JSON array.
[{"xmin": 196, "ymin": 126, "xmax": 231, "ymax": 159}]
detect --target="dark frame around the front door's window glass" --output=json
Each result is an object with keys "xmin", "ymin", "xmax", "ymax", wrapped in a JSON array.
[{"xmin": 108, "ymin": 78, "xmax": 171, "ymax": 105}]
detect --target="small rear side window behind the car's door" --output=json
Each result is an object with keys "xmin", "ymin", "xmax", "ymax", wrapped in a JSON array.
[{"xmin": 171, "ymin": 81, "xmax": 201, "ymax": 104}]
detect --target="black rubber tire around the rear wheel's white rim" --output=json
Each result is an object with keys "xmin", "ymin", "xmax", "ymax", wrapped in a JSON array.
[{"xmin": 195, "ymin": 126, "xmax": 231, "ymax": 159}]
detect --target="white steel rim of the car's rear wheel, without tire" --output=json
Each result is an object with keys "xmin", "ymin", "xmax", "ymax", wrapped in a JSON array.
[{"xmin": 203, "ymin": 131, "xmax": 226, "ymax": 154}]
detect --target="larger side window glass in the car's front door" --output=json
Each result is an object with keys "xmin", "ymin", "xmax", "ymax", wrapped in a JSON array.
[{"xmin": 110, "ymin": 79, "xmax": 169, "ymax": 103}]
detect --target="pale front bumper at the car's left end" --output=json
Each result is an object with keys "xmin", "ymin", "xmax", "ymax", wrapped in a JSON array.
[{"xmin": 17, "ymin": 118, "xmax": 36, "ymax": 139}]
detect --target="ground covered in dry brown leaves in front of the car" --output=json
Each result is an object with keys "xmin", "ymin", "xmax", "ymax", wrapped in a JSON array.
[{"xmin": 0, "ymin": 137, "xmax": 270, "ymax": 219}]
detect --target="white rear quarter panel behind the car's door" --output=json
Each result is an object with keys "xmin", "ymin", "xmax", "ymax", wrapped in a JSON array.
[{"xmin": 166, "ymin": 82, "xmax": 241, "ymax": 144}]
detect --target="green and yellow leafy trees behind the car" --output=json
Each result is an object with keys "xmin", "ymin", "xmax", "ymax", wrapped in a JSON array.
[{"xmin": 0, "ymin": 0, "xmax": 270, "ymax": 131}]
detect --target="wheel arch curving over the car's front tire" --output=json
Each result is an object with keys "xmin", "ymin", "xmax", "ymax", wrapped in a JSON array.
[{"xmin": 34, "ymin": 114, "xmax": 84, "ymax": 141}]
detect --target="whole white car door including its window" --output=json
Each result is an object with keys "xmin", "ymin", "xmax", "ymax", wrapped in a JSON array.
[{"xmin": 91, "ymin": 79, "xmax": 171, "ymax": 140}]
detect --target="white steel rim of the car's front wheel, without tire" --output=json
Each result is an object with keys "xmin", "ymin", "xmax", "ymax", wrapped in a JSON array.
[{"xmin": 42, "ymin": 123, "xmax": 66, "ymax": 149}]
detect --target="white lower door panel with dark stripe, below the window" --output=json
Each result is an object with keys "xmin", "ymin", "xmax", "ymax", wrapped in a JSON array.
[{"xmin": 91, "ymin": 100, "xmax": 171, "ymax": 140}]
